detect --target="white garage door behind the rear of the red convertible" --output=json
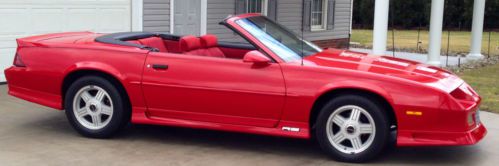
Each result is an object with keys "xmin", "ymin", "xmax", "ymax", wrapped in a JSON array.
[{"xmin": 0, "ymin": 0, "xmax": 132, "ymax": 82}]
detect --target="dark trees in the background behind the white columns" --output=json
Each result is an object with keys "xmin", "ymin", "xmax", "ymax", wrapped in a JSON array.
[{"xmin": 353, "ymin": 0, "xmax": 499, "ymax": 30}]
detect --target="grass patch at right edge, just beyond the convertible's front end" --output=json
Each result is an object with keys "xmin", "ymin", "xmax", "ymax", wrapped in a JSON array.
[{"xmin": 458, "ymin": 64, "xmax": 499, "ymax": 113}]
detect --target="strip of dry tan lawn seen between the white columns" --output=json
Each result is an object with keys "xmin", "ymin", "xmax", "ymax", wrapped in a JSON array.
[{"xmin": 351, "ymin": 29, "xmax": 499, "ymax": 55}]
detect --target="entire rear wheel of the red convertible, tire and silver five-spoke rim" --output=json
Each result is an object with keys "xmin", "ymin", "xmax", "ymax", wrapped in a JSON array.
[{"xmin": 65, "ymin": 76, "xmax": 130, "ymax": 138}]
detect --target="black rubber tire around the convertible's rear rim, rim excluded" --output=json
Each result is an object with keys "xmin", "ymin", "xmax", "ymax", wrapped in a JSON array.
[{"xmin": 64, "ymin": 76, "xmax": 131, "ymax": 138}]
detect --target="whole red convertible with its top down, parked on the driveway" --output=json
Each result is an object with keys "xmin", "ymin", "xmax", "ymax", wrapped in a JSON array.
[{"xmin": 5, "ymin": 14, "xmax": 486, "ymax": 162}]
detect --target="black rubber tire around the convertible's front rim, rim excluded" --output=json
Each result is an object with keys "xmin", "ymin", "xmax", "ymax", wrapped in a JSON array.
[{"xmin": 315, "ymin": 94, "xmax": 390, "ymax": 162}]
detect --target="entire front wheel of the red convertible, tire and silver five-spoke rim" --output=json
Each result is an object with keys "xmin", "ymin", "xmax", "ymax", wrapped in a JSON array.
[{"xmin": 316, "ymin": 95, "xmax": 390, "ymax": 162}]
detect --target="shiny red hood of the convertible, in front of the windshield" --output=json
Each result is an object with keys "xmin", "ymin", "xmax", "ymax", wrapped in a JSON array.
[{"xmin": 304, "ymin": 49, "xmax": 463, "ymax": 93}]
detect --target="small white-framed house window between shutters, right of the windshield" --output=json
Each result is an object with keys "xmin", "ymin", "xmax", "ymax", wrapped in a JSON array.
[{"xmin": 310, "ymin": 0, "xmax": 328, "ymax": 30}]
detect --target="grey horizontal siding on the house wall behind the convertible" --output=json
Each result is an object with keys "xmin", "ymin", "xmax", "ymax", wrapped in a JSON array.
[{"xmin": 144, "ymin": 0, "xmax": 351, "ymax": 41}]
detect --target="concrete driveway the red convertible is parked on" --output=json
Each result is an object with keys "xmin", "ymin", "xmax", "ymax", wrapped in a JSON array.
[{"xmin": 0, "ymin": 85, "xmax": 499, "ymax": 166}]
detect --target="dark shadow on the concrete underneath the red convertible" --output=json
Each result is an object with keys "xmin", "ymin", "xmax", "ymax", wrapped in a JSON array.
[{"xmin": 23, "ymin": 113, "xmax": 483, "ymax": 165}]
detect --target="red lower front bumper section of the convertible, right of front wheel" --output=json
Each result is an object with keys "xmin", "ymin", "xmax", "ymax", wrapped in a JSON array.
[{"xmin": 397, "ymin": 123, "xmax": 487, "ymax": 146}]
